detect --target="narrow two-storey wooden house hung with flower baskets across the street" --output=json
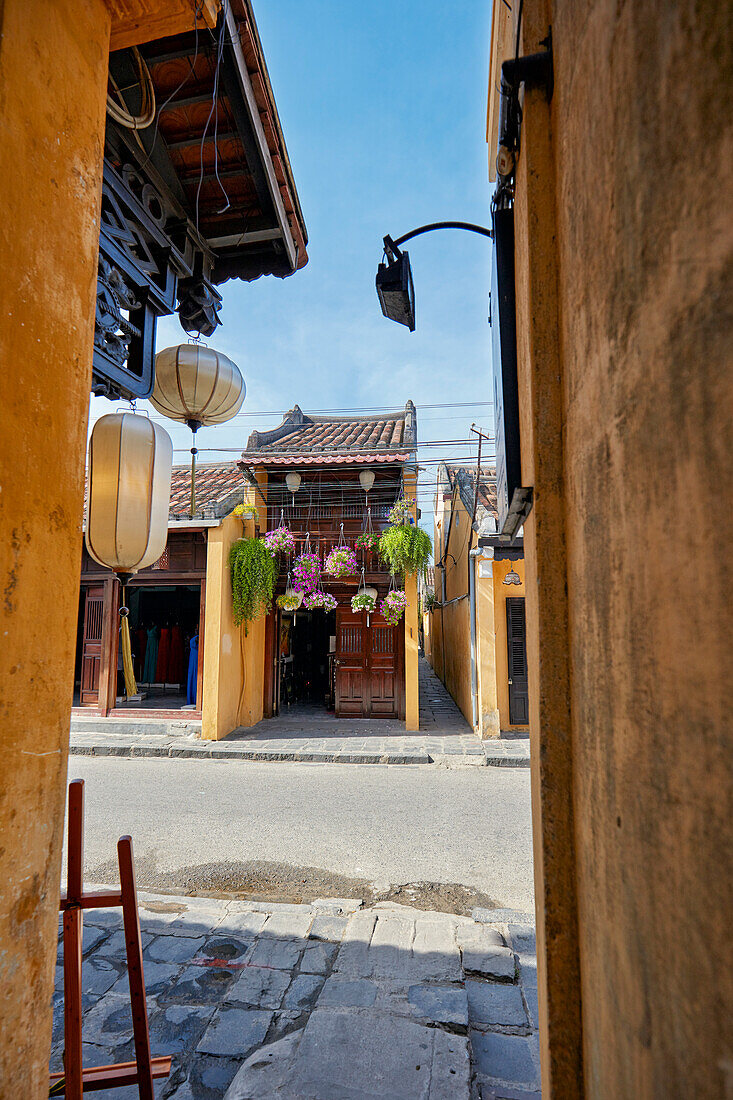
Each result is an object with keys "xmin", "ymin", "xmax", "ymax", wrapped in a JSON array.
[{"xmin": 239, "ymin": 402, "xmax": 418, "ymax": 728}]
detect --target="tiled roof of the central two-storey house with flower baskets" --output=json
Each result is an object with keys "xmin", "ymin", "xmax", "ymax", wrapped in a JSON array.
[{"xmin": 236, "ymin": 402, "xmax": 417, "ymax": 465}]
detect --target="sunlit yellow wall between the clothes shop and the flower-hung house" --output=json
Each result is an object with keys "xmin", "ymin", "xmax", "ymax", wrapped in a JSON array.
[{"xmin": 201, "ymin": 516, "xmax": 266, "ymax": 741}]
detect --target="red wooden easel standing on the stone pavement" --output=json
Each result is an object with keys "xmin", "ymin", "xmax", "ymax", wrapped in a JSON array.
[{"xmin": 51, "ymin": 779, "xmax": 171, "ymax": 1100}]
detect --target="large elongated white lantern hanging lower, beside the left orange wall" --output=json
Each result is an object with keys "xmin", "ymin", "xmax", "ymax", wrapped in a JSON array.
[{"xmin": 86, "ymin": 413, "xmax": 173, "ymax": 578}]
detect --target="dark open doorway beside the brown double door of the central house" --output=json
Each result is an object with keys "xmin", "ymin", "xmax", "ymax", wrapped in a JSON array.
[{"xmin": 280, "ymin": 611, "xmax": 336, "ymax": 715}]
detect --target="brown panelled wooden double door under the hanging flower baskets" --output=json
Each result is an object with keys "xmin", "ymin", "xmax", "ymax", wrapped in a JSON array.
[{"xmin": 336, "ymin": 608, "xmax": 405, "ymax": 718}]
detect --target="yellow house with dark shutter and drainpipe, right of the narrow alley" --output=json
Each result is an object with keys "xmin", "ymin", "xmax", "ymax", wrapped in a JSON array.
[{"xmin": 423, "ymin": 464, "xmax": 528, "ymax": 737}]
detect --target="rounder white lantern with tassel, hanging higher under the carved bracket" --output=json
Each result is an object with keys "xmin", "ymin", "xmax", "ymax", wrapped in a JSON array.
[{"xmin": 150, "ymin": 343, "xmax": 247, "ymax": 431}]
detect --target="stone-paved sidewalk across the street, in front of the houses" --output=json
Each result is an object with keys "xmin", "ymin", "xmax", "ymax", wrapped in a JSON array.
[{"xmin": 70, "ymin": 658, "xmax": 529, "ymax": 767}]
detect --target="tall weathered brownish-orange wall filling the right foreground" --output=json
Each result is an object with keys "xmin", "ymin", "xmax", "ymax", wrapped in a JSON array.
[{"xmin": 516, "ymin": 0, "xmax": 733, "ymax": 1100}]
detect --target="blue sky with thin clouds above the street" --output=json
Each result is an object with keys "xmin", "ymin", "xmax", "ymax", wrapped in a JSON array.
[{"xmin": 91, "ymin": 0, "xmax": 492, "ymax": 523}]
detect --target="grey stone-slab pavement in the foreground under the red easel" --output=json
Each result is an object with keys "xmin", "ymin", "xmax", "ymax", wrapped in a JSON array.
[{"xmin": 51, "ymin": 894, "xmax": 539, "ymax": 1100}]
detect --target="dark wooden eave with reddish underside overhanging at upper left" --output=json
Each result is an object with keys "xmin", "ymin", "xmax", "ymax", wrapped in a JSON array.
[{"xmin": 108, "ymin": 0, "xmax": 308, "ymax": 284}]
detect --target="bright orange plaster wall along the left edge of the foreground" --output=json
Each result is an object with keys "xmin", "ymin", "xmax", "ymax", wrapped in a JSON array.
[{"xmin": 0, "ymin": 0, "xmax": 110, "ymax": 1082}]
